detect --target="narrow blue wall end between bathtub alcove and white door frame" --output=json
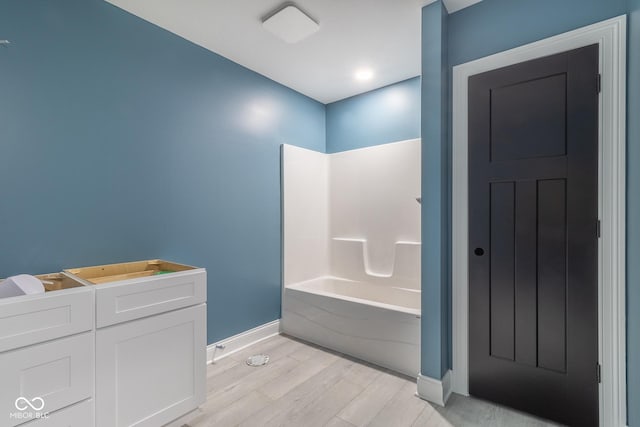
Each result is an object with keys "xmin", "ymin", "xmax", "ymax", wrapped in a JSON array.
[{"xmin": 420, "ymin": 0, "xmax": 450, "ymax": 379}]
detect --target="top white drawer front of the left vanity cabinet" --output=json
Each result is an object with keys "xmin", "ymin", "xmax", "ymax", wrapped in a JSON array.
[{"xmin": 0, "ymin": 288, "xmax": 94, "ymax": 352}]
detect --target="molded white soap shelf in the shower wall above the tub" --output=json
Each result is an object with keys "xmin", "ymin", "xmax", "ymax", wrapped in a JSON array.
[{"xmin": 331, "ymin": 237, "xmax": 421, "ymax": 281}]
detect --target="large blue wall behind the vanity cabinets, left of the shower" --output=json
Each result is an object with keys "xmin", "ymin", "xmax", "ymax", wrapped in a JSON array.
[{"xmin": 0, "ymin": 0, "xmax": 325, "ymax": 342}]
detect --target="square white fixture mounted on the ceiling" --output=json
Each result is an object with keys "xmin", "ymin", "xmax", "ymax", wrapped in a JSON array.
[{"xmin": 262, "ymin": 5, "xmax": 320, "ymax": 43}]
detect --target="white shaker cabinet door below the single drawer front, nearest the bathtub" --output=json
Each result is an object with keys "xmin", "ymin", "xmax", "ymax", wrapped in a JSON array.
[{"xmin": 96, "ymin": 304, "xmax": 206, "ymax": 427}]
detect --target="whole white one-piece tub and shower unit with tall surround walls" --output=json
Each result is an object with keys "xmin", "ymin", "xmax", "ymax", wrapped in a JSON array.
[{"xmin": 282, "ymin": 139, "xmax": 421, "ymax": 376}]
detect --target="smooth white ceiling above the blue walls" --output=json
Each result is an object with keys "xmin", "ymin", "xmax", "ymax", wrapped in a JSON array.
[{"xmin": 107, "ymin": 0, "xmax": 480, "ymax": 103}]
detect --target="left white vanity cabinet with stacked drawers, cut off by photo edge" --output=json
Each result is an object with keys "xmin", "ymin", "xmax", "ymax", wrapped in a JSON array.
[{"xmin": 0, "ymin": 273, "xmax": 94, "ymax": 427}]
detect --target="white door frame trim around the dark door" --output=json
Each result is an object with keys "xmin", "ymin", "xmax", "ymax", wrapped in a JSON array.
[{"xmin": 451, "ymin": 15, "xmax": 627, "ymax": 427}]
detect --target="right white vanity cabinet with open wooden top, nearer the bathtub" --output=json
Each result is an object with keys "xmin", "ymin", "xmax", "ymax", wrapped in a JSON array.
[{"xmin": 66, "ymin": 260, "xmax": 206, "ymax": 427}]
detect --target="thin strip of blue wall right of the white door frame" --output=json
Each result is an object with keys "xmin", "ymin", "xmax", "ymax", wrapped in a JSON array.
[{"xmin": 627, "ymin": 0, "xmax": 640, "ymax": 427}]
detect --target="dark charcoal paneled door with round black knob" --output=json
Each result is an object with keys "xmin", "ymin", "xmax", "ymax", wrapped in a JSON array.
[{"xmin": 469, "ymin": 45, "xmax": 599, "ymax": 427}]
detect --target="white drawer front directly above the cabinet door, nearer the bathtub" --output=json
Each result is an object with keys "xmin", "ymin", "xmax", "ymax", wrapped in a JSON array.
[{"xmin": 96, "ymin": 270, "xmax": 207, "ymax": 328}]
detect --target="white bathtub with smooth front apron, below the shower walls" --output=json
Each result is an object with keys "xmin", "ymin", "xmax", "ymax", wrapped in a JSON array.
[{"xmin": 282, "ymin": 277, "xmax": 420, "ymax": 377}]
